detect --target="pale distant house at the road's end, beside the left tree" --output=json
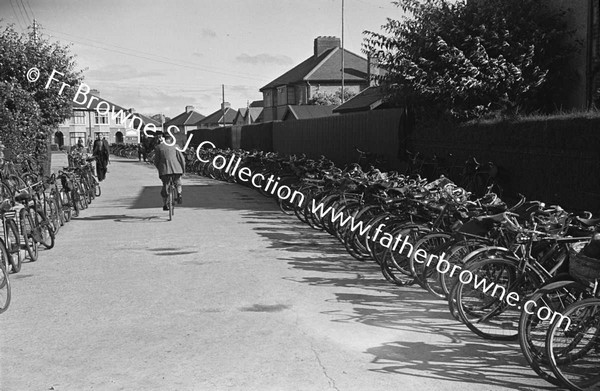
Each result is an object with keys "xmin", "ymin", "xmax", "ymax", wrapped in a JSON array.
[{"xmin": 53, "ymin": 89, "xmax": 137, "ymax": 148}]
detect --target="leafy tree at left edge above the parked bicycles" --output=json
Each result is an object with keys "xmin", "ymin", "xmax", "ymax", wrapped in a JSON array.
[{"xmin": 0, "ymin": 21, "xmax": 83, "ymax": 164}]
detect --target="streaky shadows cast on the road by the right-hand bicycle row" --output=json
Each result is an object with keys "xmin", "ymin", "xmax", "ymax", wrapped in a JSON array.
[{"xmin": 236, "ymin": 210, "xmax": 551, "ymax": 390}]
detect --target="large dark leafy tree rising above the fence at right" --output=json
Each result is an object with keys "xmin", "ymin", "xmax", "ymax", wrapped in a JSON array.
[{"xmin": 363, "ymin": 0, "xmax": 575, "ymax": 120}]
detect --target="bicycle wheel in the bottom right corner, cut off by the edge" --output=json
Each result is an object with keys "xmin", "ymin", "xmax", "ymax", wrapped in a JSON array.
[{"xmin": 546, "ymin": 299, "xmax": 600, "ymax": 391}]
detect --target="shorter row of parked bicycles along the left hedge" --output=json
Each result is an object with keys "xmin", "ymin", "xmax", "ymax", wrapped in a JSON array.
[{"xmin": 0, "ymin": 151, "xmax": 101, "ymax": 313}]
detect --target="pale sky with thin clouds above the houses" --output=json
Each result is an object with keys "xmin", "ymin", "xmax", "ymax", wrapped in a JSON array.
[{"xmin": 0, "ymin": 0, "xmax": 402, "ymax": 118}]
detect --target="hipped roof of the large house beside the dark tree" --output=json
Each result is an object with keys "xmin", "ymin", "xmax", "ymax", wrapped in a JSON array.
[{"xmin": 260, "ymin": 47, "xmax": 367, "ymax": 91}]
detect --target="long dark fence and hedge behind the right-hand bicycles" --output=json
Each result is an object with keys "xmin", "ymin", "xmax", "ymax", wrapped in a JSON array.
[{"xmin": 185, "ymin": 109, "xmax": 600, "ymax": 212}]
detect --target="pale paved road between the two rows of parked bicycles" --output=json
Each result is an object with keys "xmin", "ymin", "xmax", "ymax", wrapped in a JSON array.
[{"xmin": 0, "ymin": 155, "xmax": 546, "ymax": 391}]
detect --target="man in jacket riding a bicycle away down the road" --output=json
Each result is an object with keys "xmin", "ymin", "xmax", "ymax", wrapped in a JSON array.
[{"xmin": 154, "ymin": 132, "xmax": 185, "ymax": 210}]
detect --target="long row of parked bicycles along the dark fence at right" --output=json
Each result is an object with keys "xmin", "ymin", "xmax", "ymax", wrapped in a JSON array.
[{"xmin": 115, "ymin": 145, "xmax": 600, "ymax": 390}]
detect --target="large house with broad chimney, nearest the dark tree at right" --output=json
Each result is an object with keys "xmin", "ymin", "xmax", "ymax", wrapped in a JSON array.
[{"xmin": 260, "ymin": 37, "xmax": 369, "ymax": 122}]
